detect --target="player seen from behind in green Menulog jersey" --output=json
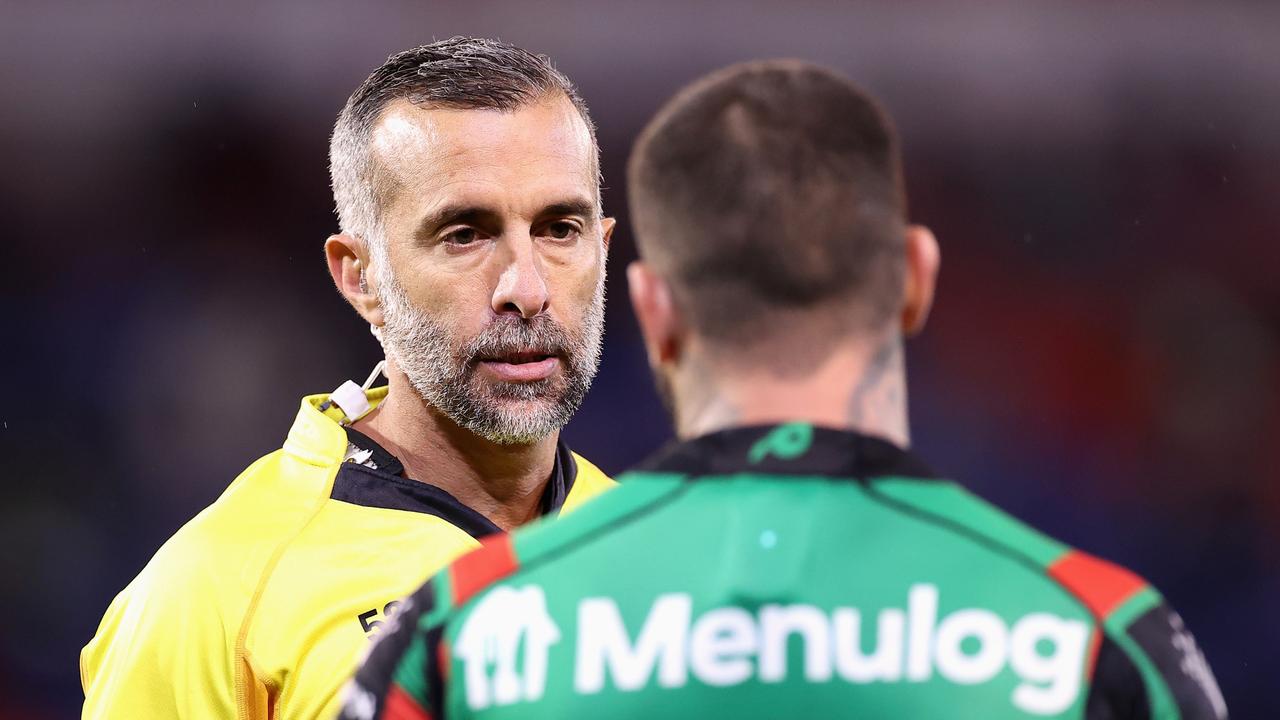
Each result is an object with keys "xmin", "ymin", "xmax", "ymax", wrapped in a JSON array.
[{"xmin": 342, "ymin": 60, "xmax": 1226, "ymax": 720}]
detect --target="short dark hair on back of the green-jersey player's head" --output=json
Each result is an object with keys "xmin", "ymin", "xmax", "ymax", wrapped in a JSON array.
[{"xmin": 627, "ymin": 60, "xmax": 906, "ymax": 346}]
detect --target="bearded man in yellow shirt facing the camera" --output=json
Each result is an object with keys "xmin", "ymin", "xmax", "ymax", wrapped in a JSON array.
[{"xmin": 81, "ymin": 37, "xmax": 613, "ymax": 720}]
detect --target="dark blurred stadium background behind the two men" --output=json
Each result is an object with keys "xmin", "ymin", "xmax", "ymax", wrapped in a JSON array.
[{"xmin": 0, "ymin": 0, "xmax": 1280, "ymax": 719}]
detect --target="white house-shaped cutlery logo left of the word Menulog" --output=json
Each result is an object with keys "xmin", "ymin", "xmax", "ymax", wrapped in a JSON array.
[{"xmin": 453, "ymin": 585, "xmax": 561, "ymax": 710}]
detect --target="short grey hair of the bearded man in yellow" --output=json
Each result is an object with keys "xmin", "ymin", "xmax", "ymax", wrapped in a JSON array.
[{"xmin": 329, "ymin": 36, "xmax": 600, "ymax": 254}]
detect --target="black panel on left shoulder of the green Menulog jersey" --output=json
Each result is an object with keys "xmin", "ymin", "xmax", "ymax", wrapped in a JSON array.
[{"xmin": 338, "ymin": 582, "xmax": 439, "ymax": 720}]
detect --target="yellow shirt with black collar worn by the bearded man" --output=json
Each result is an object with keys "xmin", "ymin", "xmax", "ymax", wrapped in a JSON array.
[{"xmin": 81, "ymin": 388, "xmax": 613, "ymax": 720}]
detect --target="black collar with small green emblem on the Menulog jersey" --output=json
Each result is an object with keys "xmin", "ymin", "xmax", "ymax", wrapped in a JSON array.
[{"xmin": 628, "ymin": 423, "xmax": 937, "ymax": 480}]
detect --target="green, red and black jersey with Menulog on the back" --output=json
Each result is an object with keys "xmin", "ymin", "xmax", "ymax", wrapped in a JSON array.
[{"xmin": 342, "ymin": 423, "xmax": 1226, "ymax": 720}]
